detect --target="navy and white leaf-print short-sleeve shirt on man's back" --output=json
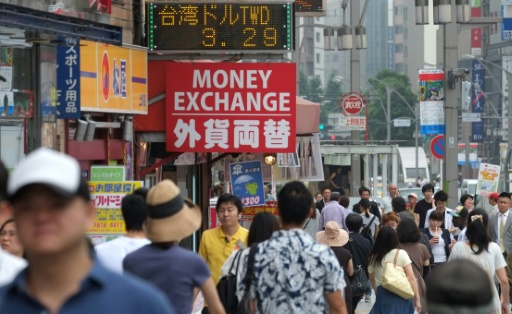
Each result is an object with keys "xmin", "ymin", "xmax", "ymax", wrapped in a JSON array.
[{"xmin": 237, "ymin": 229, "xmax": 345, "ymax": 314}]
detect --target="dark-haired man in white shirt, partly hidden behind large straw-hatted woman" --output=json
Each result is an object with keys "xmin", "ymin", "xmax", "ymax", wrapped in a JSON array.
[{"xmin": 95, "ymin": 189, "xmax": 150, "ymax": 274}]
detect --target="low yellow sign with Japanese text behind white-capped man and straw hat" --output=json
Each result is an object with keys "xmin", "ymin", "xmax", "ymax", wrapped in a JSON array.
[{"xmin": 87, "ymin": 181, "xmax": 142, "ymax": 234}]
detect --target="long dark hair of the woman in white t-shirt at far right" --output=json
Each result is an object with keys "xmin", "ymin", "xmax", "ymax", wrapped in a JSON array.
[{"xmin": 466, "ymin": 208, "xmax": 491, "ymax": 254}]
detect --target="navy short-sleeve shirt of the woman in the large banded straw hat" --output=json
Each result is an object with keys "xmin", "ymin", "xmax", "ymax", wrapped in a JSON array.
[{"xmin": 123, "ymin": 244, "xmax": 211, "ymax": 313}]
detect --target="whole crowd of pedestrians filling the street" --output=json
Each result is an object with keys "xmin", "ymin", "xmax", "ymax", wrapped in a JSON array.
[{"xmin": 0, "ymin": 149, "xmax": 512, "ymax": 314}]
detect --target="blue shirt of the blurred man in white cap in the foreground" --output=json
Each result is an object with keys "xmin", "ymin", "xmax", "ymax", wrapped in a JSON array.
[{"xmin": 0, "ymin": 261, "xmax": 176, "ymax": 314}]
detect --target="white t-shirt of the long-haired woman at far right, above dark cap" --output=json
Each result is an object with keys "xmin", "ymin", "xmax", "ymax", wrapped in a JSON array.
[{"xmin": 448, "ymin": 242, "xmax": 507, "ymax": 313}]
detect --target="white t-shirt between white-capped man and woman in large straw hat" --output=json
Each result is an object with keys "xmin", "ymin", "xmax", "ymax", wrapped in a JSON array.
[{"xmin": 94, "ymin": 237, "xmax": 151, "ymax": 274}]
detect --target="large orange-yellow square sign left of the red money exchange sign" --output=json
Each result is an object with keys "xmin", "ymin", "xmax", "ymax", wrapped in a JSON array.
[{"xmin": 80, "ymin": 40, "xmax": 148, "ymax": 114}]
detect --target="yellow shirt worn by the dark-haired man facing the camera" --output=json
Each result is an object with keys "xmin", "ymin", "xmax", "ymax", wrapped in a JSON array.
[{"xmin": 199, "ymin": 226, "xmax": 249, "ymax": 284}]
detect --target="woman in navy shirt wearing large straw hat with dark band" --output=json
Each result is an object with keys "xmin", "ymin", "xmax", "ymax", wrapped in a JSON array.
[{"xmin": 123, "ymin": 180, "xmax": 225, "ymax": 314}]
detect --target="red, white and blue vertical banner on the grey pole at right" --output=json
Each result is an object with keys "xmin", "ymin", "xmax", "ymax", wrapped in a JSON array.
[{"xmin": 419, "ymin": 70, "xmax": 444, "ymax": 134}]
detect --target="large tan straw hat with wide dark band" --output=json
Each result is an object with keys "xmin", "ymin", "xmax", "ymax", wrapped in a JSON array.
[{"xmin": 145, "ymin": 180, "xmax": 202, "ymax": 242}]
